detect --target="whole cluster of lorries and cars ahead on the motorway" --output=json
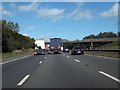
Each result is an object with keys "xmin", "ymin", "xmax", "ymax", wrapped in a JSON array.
[{"xmin": 34, "ymin": 38, "xmax": 84, "ymax": 55}]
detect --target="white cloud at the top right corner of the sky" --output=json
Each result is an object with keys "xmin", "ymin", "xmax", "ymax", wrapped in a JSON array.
[{"xmin": 100, "ymin": 3, "xmax": 118, "ymax": 17}]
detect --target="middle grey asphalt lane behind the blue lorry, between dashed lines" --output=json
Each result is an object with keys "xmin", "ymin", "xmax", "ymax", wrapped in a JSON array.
[{"xmin": 21, "ymin": 54, "xmax": 118, "ymax": 88}]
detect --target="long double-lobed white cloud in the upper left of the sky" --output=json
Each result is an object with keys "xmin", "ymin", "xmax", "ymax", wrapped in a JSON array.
[{"xmin": 19, "ymin": 2, "xmax": 64, "ymax": 21}]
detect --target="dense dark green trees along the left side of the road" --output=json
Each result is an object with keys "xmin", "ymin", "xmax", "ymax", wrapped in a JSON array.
[{"xmin": 0, "ymin": 20, "xmax": 35, "ymax": 53}]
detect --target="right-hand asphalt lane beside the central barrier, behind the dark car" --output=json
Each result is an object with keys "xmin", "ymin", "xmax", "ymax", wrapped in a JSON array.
[{"xmin": 65, "ymin": 53, "xmax": 120, "ymax": 78}]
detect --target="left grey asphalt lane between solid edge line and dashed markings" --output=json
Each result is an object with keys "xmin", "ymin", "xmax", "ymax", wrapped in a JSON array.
[{"xmin": 2, "ymin": 55, "xmax": 44, "ymax": 88}]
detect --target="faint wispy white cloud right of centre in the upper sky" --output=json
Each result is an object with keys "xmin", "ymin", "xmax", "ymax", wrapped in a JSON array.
[{"xmin": 67, "ymin": 6, "xmax": 95, "ymax": 20}]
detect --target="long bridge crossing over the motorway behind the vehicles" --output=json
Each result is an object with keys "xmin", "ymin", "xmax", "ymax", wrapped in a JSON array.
[{"xmin": 45, "ymin": 38, "xmax": 118, "ymax": 48}]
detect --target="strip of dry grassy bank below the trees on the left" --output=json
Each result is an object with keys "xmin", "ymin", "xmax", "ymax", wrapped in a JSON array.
[{"xmin": 2, "ymin": 49, "xmax": 34, "ymax": 62}]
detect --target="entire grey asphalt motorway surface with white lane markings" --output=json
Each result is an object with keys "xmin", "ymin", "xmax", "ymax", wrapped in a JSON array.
[{"xmin": 2, "ymin": 53, "xmax": 120, "ymax": 88}]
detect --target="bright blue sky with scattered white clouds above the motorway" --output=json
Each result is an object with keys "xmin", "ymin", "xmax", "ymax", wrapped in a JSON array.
[{"xmin": 0, "ymin": 2, "xmax": 118, "ymax": 40}]
